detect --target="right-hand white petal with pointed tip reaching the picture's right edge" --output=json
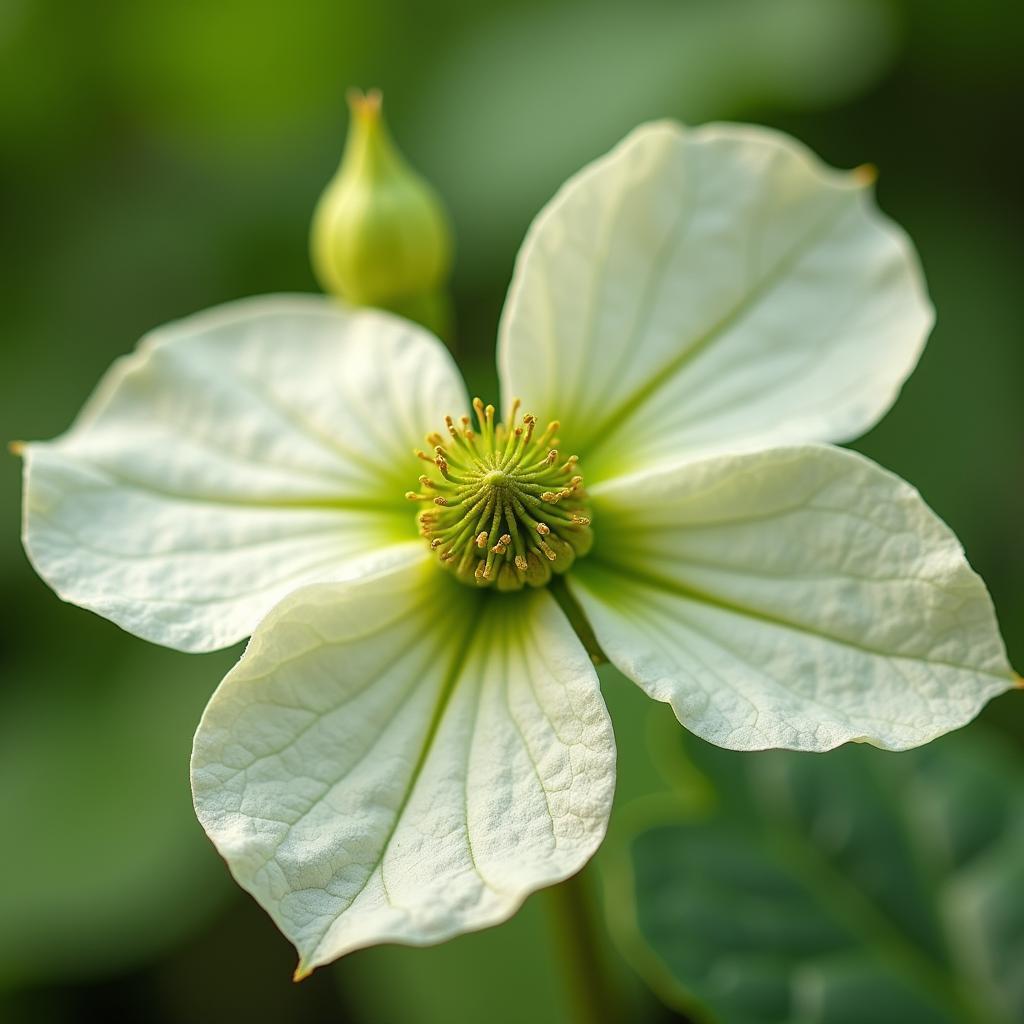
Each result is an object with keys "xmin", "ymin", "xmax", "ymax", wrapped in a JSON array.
[{"xmin": 570, "ymin": 445, "xmax": 1014, "ymax": 751}]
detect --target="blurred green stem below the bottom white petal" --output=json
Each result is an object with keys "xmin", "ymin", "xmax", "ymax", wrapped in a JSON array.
[{"xmin": 544, "ymin": 871, "xmax": 627, "ymax": 1024}]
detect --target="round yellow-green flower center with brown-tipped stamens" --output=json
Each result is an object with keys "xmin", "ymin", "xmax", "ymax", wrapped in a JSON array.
[{"xmin": 406, "ymin": 398, "xmax": 593, "ymax": 590}]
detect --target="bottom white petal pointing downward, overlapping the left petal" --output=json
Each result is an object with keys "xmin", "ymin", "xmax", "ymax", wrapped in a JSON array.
[{"xmin": 193, "ymin": 561, "xmax": 614, "ymax": 976}]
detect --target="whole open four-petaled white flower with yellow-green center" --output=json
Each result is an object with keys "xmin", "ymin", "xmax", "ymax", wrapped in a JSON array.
[{"xmin": 25, "ymin": 123, "xmax": 1014, "ymax": 976}]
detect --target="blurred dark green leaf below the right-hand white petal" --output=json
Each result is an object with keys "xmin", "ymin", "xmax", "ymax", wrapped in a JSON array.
[{"xmin": 610, "ymin": 729, "xmax": 1024, "ymax": 1024}]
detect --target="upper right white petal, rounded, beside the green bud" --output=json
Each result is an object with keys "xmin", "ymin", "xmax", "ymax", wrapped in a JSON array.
[{"xmin": 499, "ymin": 123, "xmax": 933, "ymax": 479}]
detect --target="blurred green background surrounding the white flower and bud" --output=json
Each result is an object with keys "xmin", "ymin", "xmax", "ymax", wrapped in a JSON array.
[{"xmin": 0, "ymin": 0, "xmax": 1024, "ymax": 1024}]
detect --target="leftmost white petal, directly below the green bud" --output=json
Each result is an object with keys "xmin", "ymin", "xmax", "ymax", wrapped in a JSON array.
[{"xmin": 25, "ymin": 296, "xmax": 467, "ymax": 650}]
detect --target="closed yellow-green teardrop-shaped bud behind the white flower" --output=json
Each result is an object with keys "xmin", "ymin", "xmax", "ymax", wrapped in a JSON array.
[{"xmin": 310, "ymin": 90, "xmax": 452, "ymax": 333}]
